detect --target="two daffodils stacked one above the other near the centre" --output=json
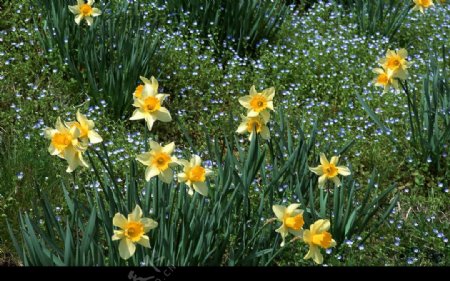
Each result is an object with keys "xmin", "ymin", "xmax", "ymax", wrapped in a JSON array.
[{"xmin": 236, "ymin": 83, "xmax": 275, "ymax": 140}]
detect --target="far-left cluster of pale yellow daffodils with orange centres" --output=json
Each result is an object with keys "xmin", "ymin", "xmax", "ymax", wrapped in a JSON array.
[{"xmin": 44, "ymin": 111, "xmax": 103, "ymax": 173}]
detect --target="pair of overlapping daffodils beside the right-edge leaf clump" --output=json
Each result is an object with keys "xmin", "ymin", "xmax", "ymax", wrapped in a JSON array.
[{"xmin": 373, "ymin": 49, "xmax": 411, "ymax": 92}]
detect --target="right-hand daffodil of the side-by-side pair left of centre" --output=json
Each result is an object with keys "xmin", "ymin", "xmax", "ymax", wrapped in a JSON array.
[{"xmin": 178, "ymin": 155, "xmax": 213, "ymax": 196}]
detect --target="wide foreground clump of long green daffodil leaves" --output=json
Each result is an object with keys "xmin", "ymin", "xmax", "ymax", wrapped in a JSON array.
[{"xmin": 8, "ymin": 113, "xmax": 395, "ymax": 265}]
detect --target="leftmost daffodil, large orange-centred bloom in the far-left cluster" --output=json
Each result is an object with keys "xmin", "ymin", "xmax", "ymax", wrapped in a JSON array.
[{"xmin": 44, "ymin": 117, "xmax": 89, "ymax": 173}]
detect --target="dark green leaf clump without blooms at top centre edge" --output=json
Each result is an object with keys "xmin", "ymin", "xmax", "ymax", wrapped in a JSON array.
[{"xmin": 165, "ymin": 0, "xmax": 288, "ymax": 55}]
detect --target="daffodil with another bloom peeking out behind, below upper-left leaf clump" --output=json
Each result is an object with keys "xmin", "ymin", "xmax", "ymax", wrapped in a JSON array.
[{"xmin": 130, "ymin": 76, "xmax": 172, "ymax": 131}]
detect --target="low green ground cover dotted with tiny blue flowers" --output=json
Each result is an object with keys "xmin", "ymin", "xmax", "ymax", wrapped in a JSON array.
[{"xmin": 0, "ymin": 1, "xmax": 450, "ymax": 266}]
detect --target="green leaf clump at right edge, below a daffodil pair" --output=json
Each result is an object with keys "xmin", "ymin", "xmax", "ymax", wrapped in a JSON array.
[{"xmin": 357, "ymin": 46, "xmax": 450, "ymax": 178}]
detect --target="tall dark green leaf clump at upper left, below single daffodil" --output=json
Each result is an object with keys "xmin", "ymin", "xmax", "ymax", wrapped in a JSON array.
[{"xmin": 35, "ymin": 0, "xmax": 165, "ymax": 118}]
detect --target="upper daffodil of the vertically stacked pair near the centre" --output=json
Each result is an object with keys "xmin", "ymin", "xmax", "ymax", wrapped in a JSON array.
[{"xmin": 239, "ymin": 86, "xmax": 275, "ymax": 122}]
